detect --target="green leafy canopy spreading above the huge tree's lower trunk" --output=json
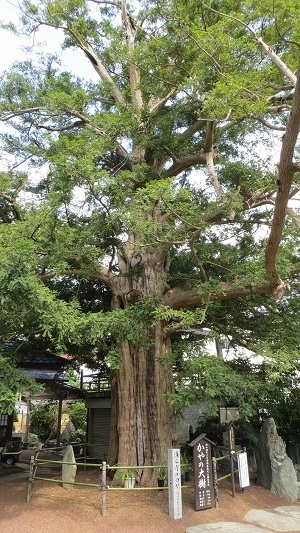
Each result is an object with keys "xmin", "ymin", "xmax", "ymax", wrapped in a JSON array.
[{"xmin": 0, "ymin": 0, "xmax": 300, "ymax": 458}]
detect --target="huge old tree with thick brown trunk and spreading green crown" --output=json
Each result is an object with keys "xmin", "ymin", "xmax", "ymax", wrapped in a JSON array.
[{"xmin": 0, "ymin": 0, "xmax": 300, "ymax": 483}]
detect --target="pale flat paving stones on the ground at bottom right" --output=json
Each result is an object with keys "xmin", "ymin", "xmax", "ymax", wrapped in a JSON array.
[{"xmin": 186, "ymin": 505, "xmax": 300, "ymax": 533}]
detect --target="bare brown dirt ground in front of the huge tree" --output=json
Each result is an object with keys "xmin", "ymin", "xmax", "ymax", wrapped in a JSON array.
[{"xmin": 0, "ymin": 448, "xmax": 300, "ymax": 533}]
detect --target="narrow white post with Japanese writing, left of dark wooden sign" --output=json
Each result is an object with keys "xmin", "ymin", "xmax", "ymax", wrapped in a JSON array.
[{"xmin": 168, "ymin": 448, "xmax": 182, "ymax": 520}]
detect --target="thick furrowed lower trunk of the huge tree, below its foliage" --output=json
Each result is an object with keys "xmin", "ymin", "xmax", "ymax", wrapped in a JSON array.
[{"xmin": 109, "ymin": 324, "xmax": 176, "ymax": 484}]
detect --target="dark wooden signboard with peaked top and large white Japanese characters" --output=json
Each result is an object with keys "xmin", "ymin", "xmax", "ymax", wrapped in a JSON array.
[{"xmin": 190, "ymin": 433, "xmax": 215, "ymax": 511}]
